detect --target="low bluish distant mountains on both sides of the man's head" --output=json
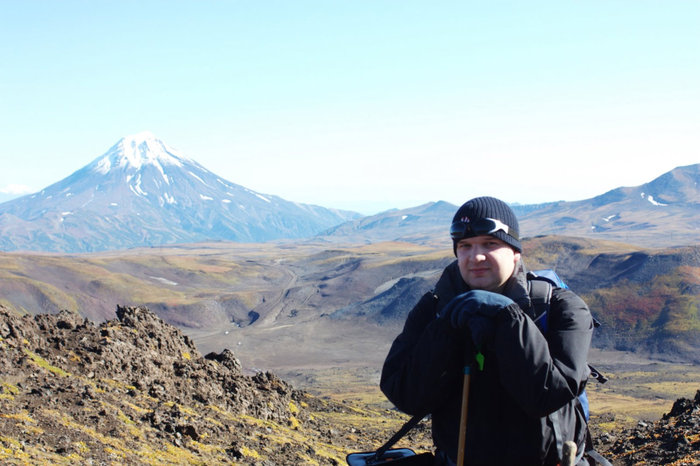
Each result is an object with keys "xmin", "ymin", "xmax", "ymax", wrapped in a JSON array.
[{"xmin": 318, "ymin": 164, "xmax": 700, "ymax": 247}]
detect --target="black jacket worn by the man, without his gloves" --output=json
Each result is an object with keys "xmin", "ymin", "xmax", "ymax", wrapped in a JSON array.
[{"xmin": 381, "ymin": 262, "xmax": 593, "ymax": 465}]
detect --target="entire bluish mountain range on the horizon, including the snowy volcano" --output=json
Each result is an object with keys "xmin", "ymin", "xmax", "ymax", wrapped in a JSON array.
[{"xmin": 0, "ymin": 131, "xmax": 700, "ymax": 253}]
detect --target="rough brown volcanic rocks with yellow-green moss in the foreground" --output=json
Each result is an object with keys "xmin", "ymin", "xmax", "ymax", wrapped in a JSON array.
[{"xmin": 0, "ymin": 307, "xmax": 700, "ymax": 466}]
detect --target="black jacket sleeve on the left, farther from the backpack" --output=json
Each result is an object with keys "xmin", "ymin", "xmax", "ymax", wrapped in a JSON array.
[{"xmin": 380, "ymin": 293, "xmax": 460, "ymax": 415}]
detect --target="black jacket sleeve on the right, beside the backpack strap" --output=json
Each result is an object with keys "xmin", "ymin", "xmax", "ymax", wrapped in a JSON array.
[{"xmin": 487, "ymin": 289, "xmax": 593, "ymax": 417}]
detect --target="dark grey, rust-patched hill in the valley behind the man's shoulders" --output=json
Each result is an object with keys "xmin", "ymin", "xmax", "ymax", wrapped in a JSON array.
[{"xmin": 331, "ymin": 236, "xmax": 700, "ymax": 364}]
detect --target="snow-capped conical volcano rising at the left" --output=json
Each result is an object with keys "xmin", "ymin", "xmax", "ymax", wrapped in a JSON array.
[{"xmin": 0, "ymin": 132, "xmax": 359, "ymax": 252}]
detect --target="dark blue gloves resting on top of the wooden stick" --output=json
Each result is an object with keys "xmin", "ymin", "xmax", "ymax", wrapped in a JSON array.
[{"xmin": 442, "ymin": 290, "xmax": 514, "ymax": 349}]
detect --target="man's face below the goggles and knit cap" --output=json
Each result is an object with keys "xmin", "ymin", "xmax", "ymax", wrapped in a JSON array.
[{"xmin": 457, "ymin": 235, "xmax": 520, "ymax": 292}]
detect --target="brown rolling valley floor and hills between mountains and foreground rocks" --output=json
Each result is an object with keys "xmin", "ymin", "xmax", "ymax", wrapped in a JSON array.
[{"xmin": 0, "ymin": 236, "xmax": 700, "ymax": 369}]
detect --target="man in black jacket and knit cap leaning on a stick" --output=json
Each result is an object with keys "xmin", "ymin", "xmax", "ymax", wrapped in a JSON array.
[{"xmin": 381, "ymin": 197, "xmax": 593, "ymax": 466}]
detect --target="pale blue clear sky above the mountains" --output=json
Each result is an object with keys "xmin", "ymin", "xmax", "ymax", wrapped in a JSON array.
[{"xmin": 0, "ymin": 0, "xmax": 700, "ymax": 214}]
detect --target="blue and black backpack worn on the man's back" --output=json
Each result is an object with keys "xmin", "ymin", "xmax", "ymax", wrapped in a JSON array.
[{"xmin": 527, "ymin": 269, "xmax": 612, "ymax": 466}]
